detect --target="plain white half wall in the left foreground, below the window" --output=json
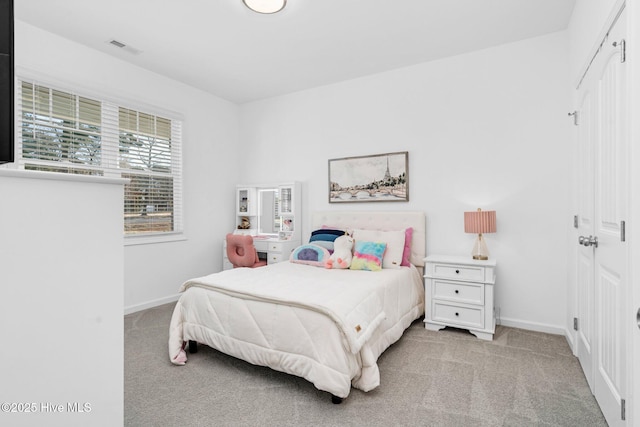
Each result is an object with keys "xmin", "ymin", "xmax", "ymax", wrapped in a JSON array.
[{"xmin": 0, "ymin": 169, "xmax": 124, "ymax": 426}]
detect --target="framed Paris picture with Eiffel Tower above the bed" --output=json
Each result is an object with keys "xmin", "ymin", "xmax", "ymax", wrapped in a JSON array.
[{"xmin": 329, "ymin": 151, "xmax": 409, "ymax": 203}]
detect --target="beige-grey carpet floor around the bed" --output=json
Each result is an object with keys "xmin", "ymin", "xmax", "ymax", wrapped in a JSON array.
[{"xmin": 124, "ymin": 303, "xmax": 607, "ymax": 427}]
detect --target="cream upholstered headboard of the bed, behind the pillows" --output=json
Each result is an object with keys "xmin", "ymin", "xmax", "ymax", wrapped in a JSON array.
[{"xmin": 311, "ymin": 211, "xmax": 427, "ymax": 267}]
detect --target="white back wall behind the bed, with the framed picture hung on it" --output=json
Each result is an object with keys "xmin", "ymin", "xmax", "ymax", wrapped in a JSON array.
[{"xmin": 240, "ymin": 32, "xmax": 570, "ymax": 333}]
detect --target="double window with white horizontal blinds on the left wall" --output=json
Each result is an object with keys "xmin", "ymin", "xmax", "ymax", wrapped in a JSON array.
[{"xmin": 17, "ymin": 81, "xmax": 182, "ymax": 236}]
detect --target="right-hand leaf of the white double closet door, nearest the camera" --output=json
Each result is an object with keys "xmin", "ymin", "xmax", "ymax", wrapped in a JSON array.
[{"xmin": 594, "ymin": 21, "xmax": 628, "ymax": 426}]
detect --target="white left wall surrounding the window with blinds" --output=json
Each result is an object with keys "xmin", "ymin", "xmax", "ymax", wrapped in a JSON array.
[{"xmin": 15, "ymin": 21, "xmax": 239, "ymax": 311}]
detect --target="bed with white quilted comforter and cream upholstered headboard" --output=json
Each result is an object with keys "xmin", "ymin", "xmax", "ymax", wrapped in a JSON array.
[{"xmin": 168, "ymin": 212, "xmax": 426, "ymax": 403}]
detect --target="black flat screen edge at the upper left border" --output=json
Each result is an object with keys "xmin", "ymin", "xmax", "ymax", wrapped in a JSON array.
[{"xmin": 0, "ymin": 0, "xmax": 15, "ymax": 163}]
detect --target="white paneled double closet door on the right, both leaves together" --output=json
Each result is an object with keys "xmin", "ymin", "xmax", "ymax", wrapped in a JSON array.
[{"xmin": 577, "ymin": 7, "xmax": 630, "ymax": 426}]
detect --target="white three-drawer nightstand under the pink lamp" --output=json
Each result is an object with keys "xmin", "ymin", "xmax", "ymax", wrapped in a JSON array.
[{"xmin": 424, "ymin": 255, "xmax": 496, "ymax": 341}]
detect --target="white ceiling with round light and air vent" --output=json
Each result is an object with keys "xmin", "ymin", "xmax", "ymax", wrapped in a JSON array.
[{"xmin": 15, "ymin": 0, "xmax": 576, "ymax": 104}]
